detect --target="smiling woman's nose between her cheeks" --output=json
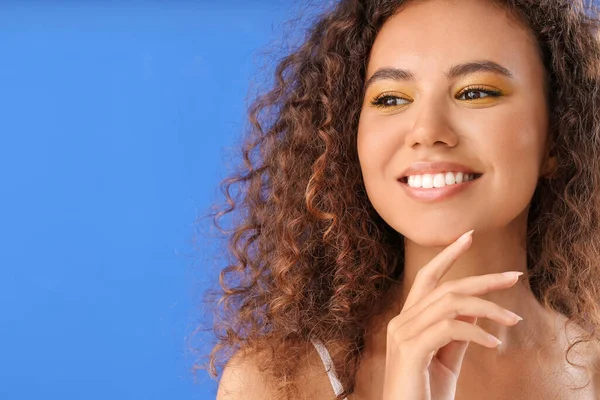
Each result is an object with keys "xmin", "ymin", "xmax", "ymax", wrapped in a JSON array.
[{"xmin": 405, "ymin": 100, "xmax": 458, "ymax": 148}]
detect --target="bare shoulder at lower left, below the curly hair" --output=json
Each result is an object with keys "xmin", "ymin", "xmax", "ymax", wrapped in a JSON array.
[{"xmin": 217, "ymin": 351, "xmax": 275, "ymax": 400}]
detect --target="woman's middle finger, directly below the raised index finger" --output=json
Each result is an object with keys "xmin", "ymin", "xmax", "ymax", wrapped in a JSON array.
[{"xmin": 402, "ymin": 271, "xmax": 522, "ymax": 321}]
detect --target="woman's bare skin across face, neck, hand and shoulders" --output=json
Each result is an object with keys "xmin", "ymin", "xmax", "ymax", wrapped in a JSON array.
[{"xmin": 218, "ymin": 0, "xmax": 598, "ymax": 400}]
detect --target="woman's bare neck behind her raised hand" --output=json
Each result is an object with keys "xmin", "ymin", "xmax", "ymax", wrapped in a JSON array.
[{"xmin": 367, "ymin": 216, "xmax": 549, "ymax": 356}]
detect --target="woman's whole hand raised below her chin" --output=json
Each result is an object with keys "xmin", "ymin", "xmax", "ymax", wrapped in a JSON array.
[{"xmin": 383, "ymin": 231, "xmax": 521, "ymax": 400}]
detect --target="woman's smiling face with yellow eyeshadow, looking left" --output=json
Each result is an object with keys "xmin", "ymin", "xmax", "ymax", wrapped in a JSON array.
[{"xmin": 357, "ymin": 0, "xmax": 548, "ymax": 246}]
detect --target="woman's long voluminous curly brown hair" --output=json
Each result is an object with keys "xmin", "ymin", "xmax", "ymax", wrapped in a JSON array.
[{"xmin": 190, "ymin": 0, "xmax": 600, "ymax": 399}]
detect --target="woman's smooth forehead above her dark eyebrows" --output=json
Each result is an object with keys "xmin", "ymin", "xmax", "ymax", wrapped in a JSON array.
[{"xmin": 367, "ymin": 0, "xmax": 543, "ymax": 79}]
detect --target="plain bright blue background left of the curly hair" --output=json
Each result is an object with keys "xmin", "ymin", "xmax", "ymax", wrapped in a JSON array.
[{"xmin": 0, "ymin": 0, "xmax": 324, "ymax": 400}]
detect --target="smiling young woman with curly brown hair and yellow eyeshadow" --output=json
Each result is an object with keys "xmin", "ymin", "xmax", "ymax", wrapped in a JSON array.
[{"xmin": 200, "ymin": 0, "xmax": 600, "ymax": 400}]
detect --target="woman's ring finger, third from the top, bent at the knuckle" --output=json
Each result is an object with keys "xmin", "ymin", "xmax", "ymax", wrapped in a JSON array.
[{"xmin": 396, "ymin": 293, "xmax": 520, "ymax": 343}]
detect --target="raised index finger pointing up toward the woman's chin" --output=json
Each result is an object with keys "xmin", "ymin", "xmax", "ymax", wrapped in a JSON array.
[{"xmin": 402, "ymin": 230, "xmax": 473, "ymax": 310}]
